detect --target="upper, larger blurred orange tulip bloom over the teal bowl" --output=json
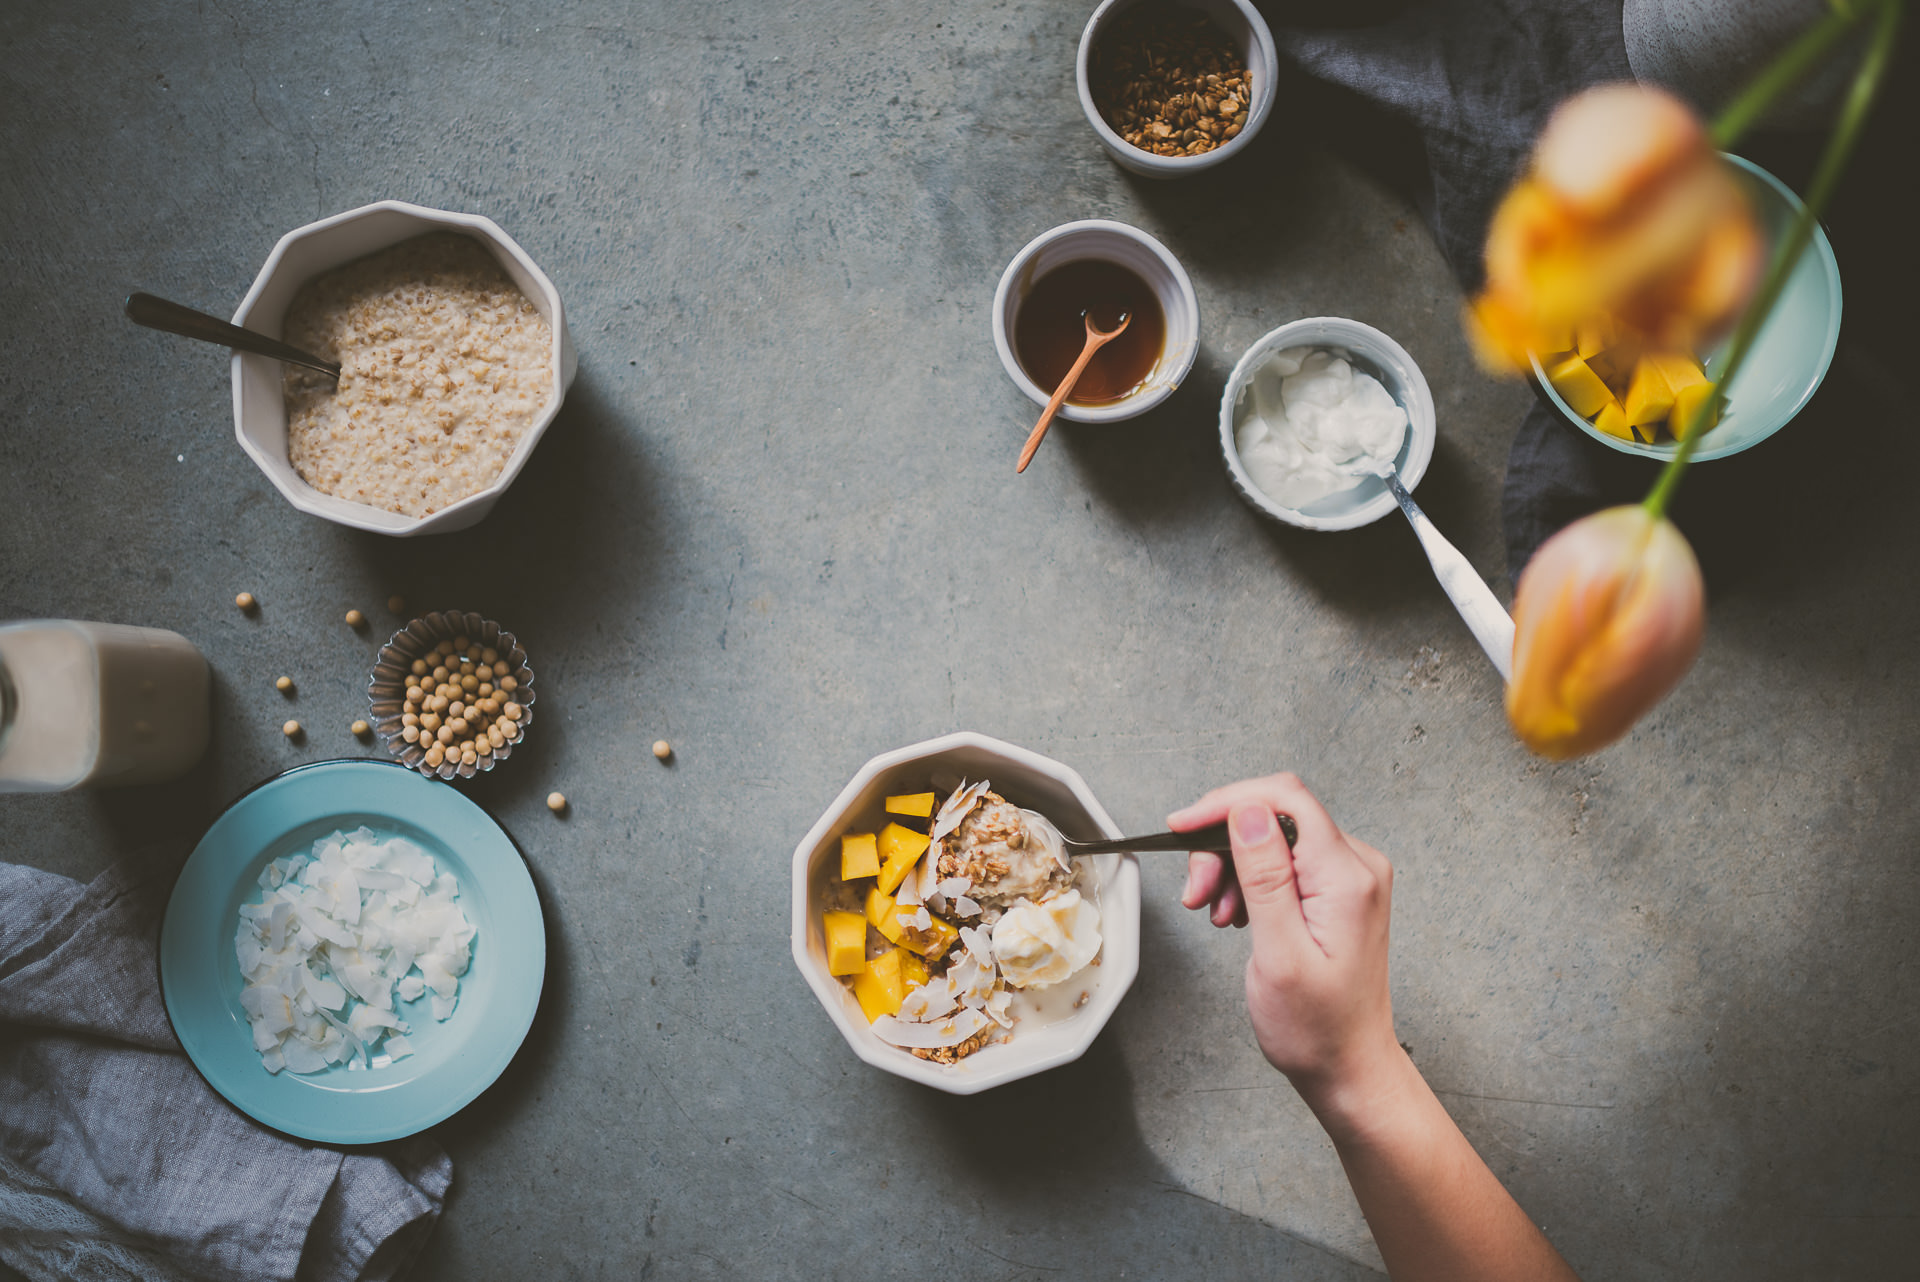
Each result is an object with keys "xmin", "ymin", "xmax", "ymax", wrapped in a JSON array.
[{"xmin": 1465, "ymin": 84, "xmax": 1764, "ymax": 372}]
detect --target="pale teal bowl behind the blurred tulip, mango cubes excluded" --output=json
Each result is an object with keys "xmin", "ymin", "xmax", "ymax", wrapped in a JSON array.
[{"xmin": 1532, "ymin": 155, "xmax": 1839, "ymax": 463}]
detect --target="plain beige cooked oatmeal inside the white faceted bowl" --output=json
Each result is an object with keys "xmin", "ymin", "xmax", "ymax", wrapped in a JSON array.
[{"xmin": 286, "ymin": 232, "xmax": 555, "ymax": 516}]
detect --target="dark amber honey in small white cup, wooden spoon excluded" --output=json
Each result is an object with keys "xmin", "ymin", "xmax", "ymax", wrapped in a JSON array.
[{"xmin": 1014, "ymin": 259, "xmax": 1167, "ymax": 405}]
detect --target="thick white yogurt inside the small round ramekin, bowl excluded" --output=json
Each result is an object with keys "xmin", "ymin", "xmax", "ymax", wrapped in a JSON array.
[{"xmin": 1233, "ymin": 347, "xmax": 1407, "ymax": 509}]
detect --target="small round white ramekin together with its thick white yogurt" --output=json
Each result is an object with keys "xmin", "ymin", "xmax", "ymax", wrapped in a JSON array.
[{"xmin": 1219, "ymin": 317, "xmax": 1434, "ymax": 530}]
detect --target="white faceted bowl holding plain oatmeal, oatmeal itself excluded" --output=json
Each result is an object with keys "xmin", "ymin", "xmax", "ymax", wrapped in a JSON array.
[{"xmin": 232, "ymin": 200, "xmax": 580, "ymax": 537}]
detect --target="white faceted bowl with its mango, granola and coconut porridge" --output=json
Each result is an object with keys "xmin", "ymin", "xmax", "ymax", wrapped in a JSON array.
[{"xmin": 793, "ymin": 731, "xmax": 1140, "ymax": 1096}]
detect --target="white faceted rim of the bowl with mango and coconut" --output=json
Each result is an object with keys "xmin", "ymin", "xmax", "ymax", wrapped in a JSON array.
[{"xmin": 793, "ymin": 731, "xmax": 1140, "ymax": 1096}]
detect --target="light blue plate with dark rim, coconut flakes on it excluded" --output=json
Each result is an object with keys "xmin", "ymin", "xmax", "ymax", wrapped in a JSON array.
[{"xmin": 159, "ymin": 760, "xmax": 547, "ymax": 1144}]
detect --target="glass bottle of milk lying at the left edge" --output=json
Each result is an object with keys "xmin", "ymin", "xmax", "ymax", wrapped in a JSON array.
[{"xmin": 0, "ymin": 618, "xmax": 209, "ymax": 793}]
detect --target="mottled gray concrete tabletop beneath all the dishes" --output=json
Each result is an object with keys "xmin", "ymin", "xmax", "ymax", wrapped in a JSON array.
[{"xmin": 0, "ymin": 0, "xmax": 1920, "ymax": 1278}]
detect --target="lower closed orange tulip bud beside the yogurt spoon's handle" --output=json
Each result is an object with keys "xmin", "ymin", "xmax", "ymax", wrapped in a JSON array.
[{"xmin": 1507, "ymin": 505, "xmax": 1707, "ymax": 760}]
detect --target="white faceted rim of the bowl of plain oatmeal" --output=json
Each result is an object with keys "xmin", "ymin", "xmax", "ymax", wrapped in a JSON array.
[{"xmin": 230, "ymin": 200, "xmax": 576, "ymax": 537}]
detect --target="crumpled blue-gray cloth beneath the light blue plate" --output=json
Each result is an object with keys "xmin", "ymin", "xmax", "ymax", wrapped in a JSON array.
[{"xmin": 0, "ymin": 854, "xmax": 453, "ymax": 1282}]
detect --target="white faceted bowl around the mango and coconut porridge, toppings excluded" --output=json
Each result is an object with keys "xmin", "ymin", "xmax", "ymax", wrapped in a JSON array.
[{"xmin": 793, "ymin": 731, "xmax": 1140, "ymax": 1096}]
